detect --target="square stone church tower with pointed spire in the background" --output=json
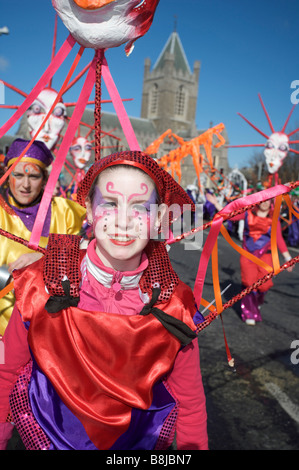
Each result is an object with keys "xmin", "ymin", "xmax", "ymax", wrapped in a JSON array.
[{"xmin": 141, "ymin": 32, "xmax": 200, "ymax": 136}]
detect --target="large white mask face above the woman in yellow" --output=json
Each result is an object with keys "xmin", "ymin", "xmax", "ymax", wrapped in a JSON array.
[{"xmin": 27, "ymin": 88, "xmax": 66, "ymax": 150}]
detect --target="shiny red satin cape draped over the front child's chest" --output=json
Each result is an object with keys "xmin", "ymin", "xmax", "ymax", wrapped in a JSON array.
[{"xmin": 11, "ymin": 263, "xmax": 204, "ymax": 449}]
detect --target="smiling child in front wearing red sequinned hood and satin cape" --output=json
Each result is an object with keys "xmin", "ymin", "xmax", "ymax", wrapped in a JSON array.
[{"xmin": 0, "ymin": 151, "xmax": 208, "ymax": 450}]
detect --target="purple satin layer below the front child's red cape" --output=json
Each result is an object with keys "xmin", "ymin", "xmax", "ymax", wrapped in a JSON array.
[{"xmin": 28, "ymin": 360, "xmax": 175, "ymax": 450}]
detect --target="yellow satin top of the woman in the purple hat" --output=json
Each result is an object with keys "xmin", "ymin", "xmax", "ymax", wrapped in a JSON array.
[{"xmin": 0, "ymin": 197, "xmax": 86, "ymax": 336}]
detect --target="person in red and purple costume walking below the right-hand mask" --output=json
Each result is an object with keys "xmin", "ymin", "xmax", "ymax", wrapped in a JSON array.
[{"xmin": 231, "ymin": 200, "xmax": 293, "ymax": 325}]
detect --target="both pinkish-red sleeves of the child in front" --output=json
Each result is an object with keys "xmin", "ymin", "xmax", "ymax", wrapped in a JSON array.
[{"xmin": 0, "ymin": 307, "xmax": 208, "ymax": 450}]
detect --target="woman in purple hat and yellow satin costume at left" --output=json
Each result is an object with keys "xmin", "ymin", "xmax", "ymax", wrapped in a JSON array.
[{"xmin": 0, "ymin": 139, "xmax": 85, "ymax": 335}]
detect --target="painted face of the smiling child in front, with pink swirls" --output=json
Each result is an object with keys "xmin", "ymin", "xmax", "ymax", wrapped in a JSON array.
[{"xmin": 87, "ymin": 168, "xmax": 156, "ymax": 270}]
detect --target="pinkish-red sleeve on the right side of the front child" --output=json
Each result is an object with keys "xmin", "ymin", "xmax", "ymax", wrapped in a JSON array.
[{"xmin": 167, "ymin": 338, "xmax": 208, "ymax": 450}]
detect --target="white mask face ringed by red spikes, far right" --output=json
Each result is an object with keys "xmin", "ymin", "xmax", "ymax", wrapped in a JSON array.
[{"xmin": 264, "ymin": 132, "xmax": 289, "ymax": 174}]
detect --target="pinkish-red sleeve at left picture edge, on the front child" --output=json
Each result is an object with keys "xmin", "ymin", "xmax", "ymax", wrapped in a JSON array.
[{"xmin": 0, "ymin": 307, "xmax": 30, "ymax": 449}]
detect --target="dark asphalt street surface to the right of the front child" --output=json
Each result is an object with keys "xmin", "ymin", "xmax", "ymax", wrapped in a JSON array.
[{"xmin": 169, "ymin": 229, "xmax": 299, "ymax": 450}]
